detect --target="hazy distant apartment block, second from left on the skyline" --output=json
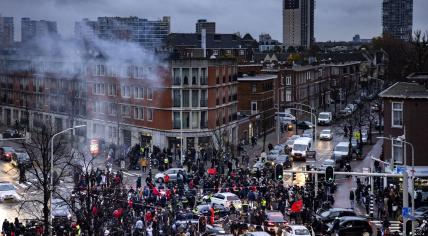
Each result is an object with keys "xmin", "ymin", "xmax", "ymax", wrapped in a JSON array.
[{"xmin": 21, "ymin": 17, "xmax": 58, "ymax": 42}]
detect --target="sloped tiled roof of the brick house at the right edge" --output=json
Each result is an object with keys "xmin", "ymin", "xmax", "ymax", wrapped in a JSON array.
[{"xmin": 379, "ymin": 82, "xmax": 428, "ymax": 99}]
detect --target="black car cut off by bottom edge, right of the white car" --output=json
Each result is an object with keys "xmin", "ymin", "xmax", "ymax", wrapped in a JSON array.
[{"xmin": 327, "ymin": 216, "xmax": 373, "ymax": 236}]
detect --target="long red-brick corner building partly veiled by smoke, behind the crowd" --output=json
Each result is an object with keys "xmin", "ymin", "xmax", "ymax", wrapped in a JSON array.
[{"xmin": 0, "ymin": 56, "xmax": 238, "ymax": 152}]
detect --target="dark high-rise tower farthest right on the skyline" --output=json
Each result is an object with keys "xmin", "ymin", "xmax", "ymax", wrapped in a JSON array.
[{"xmin": 382, "ymin": 0, "xmax": 413, "ymax": 41}]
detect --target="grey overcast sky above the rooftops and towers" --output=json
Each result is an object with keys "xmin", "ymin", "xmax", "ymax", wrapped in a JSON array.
[{"xmin": 0, "ymin": 0, "xmax": 428, "ymax": 41}]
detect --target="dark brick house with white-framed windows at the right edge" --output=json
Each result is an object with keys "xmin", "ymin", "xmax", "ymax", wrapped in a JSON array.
[{"xmin": 379, "ymin": 73, "xmax": 428, "ymax": 176}]
